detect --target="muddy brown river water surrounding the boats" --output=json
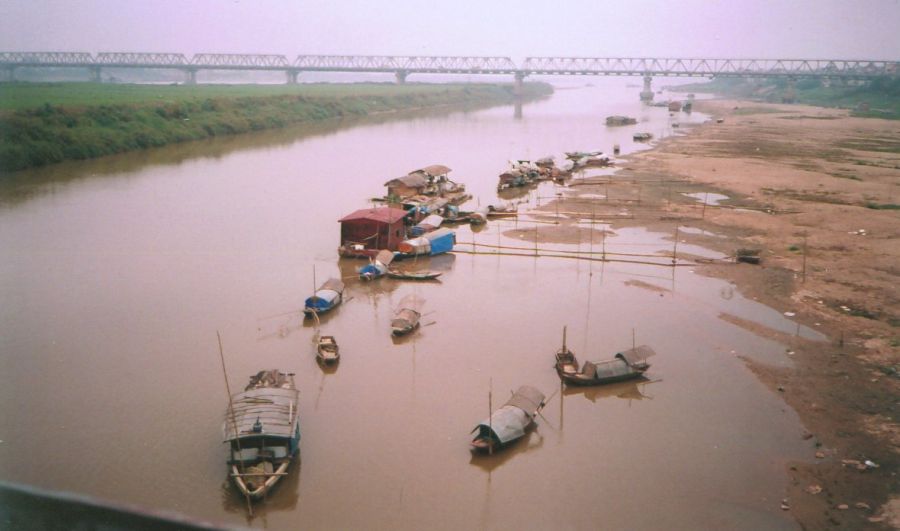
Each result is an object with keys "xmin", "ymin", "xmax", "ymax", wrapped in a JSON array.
[{"xmin": 0, "ymin": 80, "xmax": 816, "ymax": 529}]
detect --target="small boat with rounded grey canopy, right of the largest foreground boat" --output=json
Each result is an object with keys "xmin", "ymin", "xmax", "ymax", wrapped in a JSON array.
[{"xmin": 472, "ymin": 385, "xmax": 545, "ymax": 452}]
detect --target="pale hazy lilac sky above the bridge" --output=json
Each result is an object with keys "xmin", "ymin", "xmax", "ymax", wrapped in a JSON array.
[{"xmin": 0, "ymin": 0, "xmax": 900, "ymax": 61}]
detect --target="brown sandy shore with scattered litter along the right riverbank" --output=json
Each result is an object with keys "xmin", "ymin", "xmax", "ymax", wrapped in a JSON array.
[{"xmin": 542, "ymin": 100, "xmax": 900, "ymax": 529}]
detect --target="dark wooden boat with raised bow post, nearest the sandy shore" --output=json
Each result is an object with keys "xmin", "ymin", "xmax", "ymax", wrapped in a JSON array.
[{"xmin": 556, "ymin": 328, "xmax": 656, "ymax": 385}]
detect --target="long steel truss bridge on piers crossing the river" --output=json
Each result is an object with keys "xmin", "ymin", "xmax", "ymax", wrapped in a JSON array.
[{"xmin": 0, "ymin": 52, "xmax": 900, "ymax": 97}]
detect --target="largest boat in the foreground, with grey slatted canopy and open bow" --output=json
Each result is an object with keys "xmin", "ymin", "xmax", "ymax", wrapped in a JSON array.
[{"xmin": 223, "ymin": 369, "xmax": 300, "ymax": 500}]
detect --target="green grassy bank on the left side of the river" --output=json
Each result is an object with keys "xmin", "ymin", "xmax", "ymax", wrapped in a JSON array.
[{"xmin": 0, "ymin": 83, "xmax": 553, "ymax": 172}]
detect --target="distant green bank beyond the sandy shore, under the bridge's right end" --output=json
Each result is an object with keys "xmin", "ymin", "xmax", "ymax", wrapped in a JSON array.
[{"xmin": 673, "ymin": 78, "xmax": 900, "ymax": 120}]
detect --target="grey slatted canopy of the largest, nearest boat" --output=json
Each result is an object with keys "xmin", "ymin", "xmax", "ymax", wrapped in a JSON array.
[{"xmin": 223, "ymin": 387, "xmax": 300, "ymax": 441}]
